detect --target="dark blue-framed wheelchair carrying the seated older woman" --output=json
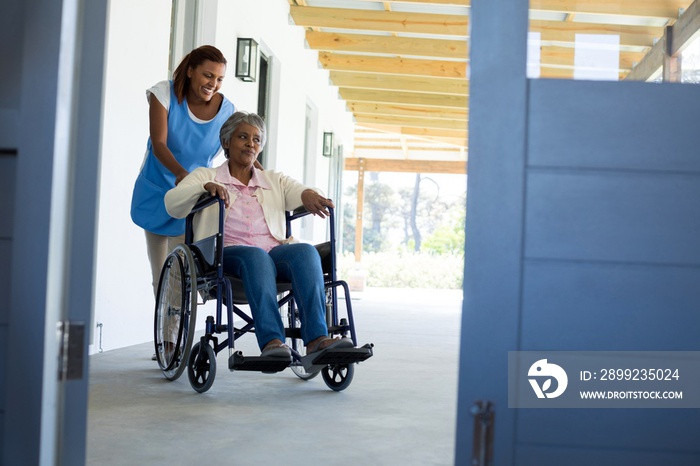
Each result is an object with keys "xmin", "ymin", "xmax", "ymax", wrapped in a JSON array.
[{"xmin": 154, "ymin": 194, "xmax": 374, "ymax": 393}]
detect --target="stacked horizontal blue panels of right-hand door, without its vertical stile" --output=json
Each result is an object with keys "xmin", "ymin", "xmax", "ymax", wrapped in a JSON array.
[{"xmin": 514, "ymin": 80, "xmax": 700, "ymax": 458}]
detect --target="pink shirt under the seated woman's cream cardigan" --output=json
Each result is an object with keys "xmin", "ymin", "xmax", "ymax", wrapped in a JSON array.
[{"xmin": 214, "ymin": 163, "xmax": 280, "ymax": 252}]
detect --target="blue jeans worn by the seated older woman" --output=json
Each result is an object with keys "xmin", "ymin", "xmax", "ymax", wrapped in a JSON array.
[{"xmin": 224, "ymin": 243, "xmax": 328, "ymax": 349}]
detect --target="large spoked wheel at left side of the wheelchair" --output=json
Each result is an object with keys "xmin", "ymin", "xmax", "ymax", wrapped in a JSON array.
[{"xmin": 153, "ymin": 244, "xmax": 197, "ymax": 380}]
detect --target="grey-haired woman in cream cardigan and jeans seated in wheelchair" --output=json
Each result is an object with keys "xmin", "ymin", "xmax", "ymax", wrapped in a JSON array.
[{"xmin": 165, "ymin": 112, "xmax": 353, "ymax": 361}]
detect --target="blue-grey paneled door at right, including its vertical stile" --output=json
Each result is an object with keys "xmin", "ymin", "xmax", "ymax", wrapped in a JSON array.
[{"xmin": 456, "ymin": 0, "xmax": 700, "ymax": 466}]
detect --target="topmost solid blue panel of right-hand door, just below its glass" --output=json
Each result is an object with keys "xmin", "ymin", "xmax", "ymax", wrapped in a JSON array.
[{"xmin": 527, "ymin": 80, "xmax": 700, "ymax": 172}]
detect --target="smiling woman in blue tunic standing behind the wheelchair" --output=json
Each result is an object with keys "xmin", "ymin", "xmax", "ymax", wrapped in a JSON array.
[{"xmin": 131, "ymin": 45, "xmax": 235, "ymax": 295}]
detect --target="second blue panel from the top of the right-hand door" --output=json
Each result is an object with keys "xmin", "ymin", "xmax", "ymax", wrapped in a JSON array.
[{"xmin": 525, "ymin": 169, "xmax": 700, "ymax": 265}]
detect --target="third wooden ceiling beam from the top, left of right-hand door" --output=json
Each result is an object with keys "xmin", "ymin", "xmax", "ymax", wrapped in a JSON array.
[{"xmin": 318, "ymin": 52, "xmax": 467, "ymax": 79}]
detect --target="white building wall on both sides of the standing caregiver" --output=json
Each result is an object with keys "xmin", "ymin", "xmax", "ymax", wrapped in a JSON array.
[{"xmin": 91, "ymin": 0, "xmax": 353, "ymax": 358}]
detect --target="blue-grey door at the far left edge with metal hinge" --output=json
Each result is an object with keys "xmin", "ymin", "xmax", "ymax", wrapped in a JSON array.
[{"xmin": 0, "ymin": 0, "xmax": 108, "ymax": 465}]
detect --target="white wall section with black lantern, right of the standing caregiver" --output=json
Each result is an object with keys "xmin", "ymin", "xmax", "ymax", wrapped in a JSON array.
[{"xmin": 216, "ymin": 0, "xmax": 354, "ymax": 242}]
